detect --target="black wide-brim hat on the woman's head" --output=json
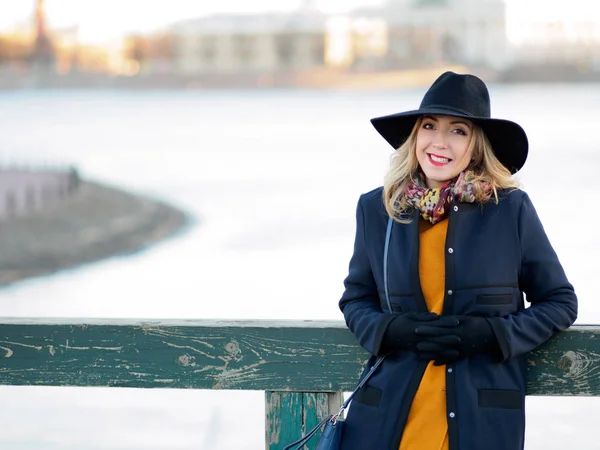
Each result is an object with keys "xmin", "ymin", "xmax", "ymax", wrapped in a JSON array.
[{"xmin": 371, "ymin": 72, "xmax": 529, "ymax": 173}]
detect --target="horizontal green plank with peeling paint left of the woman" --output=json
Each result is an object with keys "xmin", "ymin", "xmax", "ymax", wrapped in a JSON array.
[{"xmin": 0, "ymin": 319, "xmax": 367, "ymax": 391}]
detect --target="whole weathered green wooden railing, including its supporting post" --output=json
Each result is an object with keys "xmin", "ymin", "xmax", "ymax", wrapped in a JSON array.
[{"xmin": 0, "ymin": 318, "xmax": 600, "ymax": 450}]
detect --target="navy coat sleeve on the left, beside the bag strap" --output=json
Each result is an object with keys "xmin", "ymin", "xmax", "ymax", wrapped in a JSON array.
[{"xmin": 339, "ymin": 195, "xmax": 394, "ymax": 355}]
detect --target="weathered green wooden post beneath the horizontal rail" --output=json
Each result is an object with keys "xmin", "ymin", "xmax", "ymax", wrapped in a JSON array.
[{"xmin": 265, "ymin": 391, "xmax": 343, "ymax": 450}]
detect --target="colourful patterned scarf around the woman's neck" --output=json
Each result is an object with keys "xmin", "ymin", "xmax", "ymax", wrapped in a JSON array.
[{"xmin": 404, "ymin": 170, "xmax": 492, "ymax": 224}]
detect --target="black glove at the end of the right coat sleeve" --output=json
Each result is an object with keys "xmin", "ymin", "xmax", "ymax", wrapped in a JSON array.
[{"xmin": 416, "ymin": 316, "xmax": 500, "ymax": 366}]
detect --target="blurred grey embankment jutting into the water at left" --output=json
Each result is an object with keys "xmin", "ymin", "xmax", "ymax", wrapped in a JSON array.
[{"xmin": 0, "ymin": 166, "xmax": 189, "ymax": 286}]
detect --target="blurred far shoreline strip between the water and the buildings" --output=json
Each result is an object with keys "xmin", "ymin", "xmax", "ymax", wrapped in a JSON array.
[{"xmin": 0, "ymin": 65, "xmax": 600, "ymax": 91}]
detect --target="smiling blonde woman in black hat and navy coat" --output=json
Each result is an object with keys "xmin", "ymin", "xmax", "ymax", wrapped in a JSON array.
[{"xmin": 340, "ymin": 72, "xmax": 577, "ymax": 450}]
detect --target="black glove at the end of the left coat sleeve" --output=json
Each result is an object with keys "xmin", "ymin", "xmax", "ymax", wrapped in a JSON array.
[{"xmin": 381, "ymin": 312, "xmax": 458, "ymax": 351}]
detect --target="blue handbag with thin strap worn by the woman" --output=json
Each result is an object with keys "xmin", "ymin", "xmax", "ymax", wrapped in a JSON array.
[{"xmin": 283, "ymin": 217, "xmax": 394, "ymax": 450}]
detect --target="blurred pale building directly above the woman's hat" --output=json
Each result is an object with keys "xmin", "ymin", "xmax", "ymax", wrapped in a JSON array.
[{"xmin": 349, "ymin": 0, "xmax": 511, "ymax": 70}]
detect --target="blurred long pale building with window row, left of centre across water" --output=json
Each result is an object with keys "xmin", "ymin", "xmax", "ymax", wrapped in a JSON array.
[{"xmin": 171, "ymin": 10, "xmax": 326, "ymax": 75}]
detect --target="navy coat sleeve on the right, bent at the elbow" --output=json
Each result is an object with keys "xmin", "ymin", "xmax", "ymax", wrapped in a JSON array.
[{"xmin": 490, "ymin": 194, "xmax": 577, "ymax": 360}]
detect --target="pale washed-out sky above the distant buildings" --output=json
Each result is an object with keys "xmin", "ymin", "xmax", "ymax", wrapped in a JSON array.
[{"xmin": 0, "ymin": 0, "xmax": 600, "ymax": 42}]
